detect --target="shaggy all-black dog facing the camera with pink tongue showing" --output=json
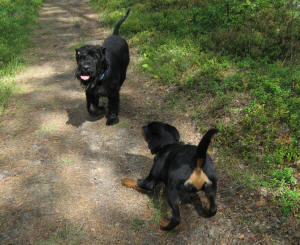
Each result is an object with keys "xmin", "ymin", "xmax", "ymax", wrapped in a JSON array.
[{"xmin": 75, "ymin": 9, "xmax": 130, "ymax": 125}]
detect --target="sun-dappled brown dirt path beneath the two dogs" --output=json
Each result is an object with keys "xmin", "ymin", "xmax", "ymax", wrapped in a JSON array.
[{"xmin": 0, "ymin": 0, "xmax": 291, "ymax": 244}]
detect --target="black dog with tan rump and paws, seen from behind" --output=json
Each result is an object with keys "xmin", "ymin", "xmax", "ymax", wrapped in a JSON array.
[{"xmin": 122, "ymin": 122, "xmax": 217, "ymax": 230}]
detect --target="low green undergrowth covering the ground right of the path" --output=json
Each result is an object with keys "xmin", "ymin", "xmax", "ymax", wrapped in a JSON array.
[{"xmin": 91, "ymin": 0, "xmax": 300, "ymax": 215}]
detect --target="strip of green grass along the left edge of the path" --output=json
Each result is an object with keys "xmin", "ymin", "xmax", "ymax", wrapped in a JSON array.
[{"xmin": 0, "ymin": 0, "xmax": 43, "ymax": 113}]
